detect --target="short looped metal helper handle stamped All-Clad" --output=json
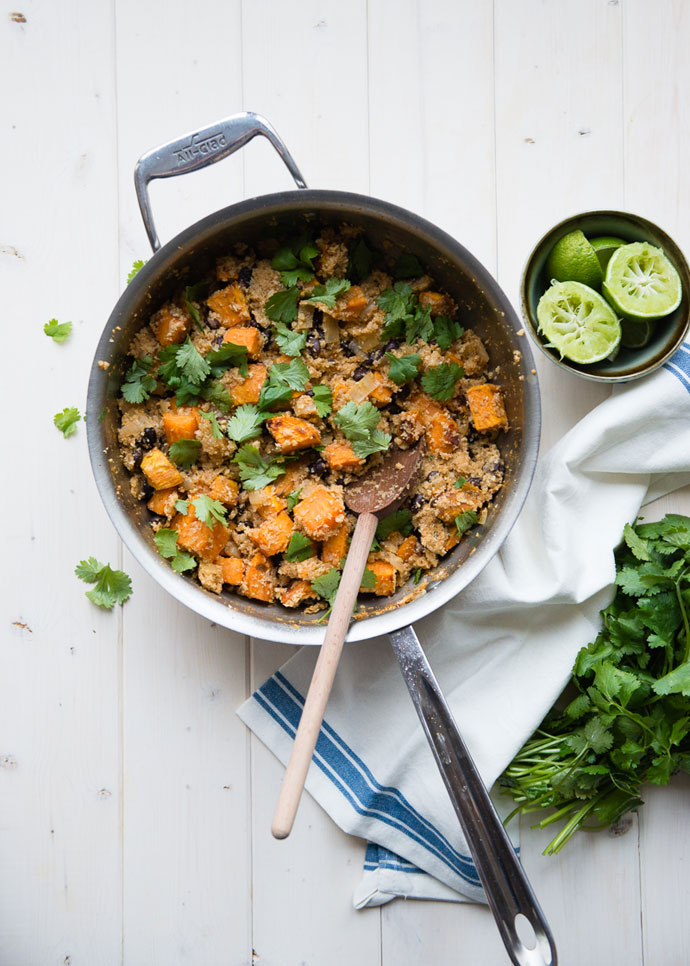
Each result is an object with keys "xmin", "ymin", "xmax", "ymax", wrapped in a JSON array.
[{"xmin": 134, "ymin": 111, "xmax": 307, "ymax": 252}]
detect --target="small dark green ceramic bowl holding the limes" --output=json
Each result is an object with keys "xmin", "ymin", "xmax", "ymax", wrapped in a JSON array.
[{"xmin": 520, "ymin": 211, "xmax": 690, "ymax": 382}]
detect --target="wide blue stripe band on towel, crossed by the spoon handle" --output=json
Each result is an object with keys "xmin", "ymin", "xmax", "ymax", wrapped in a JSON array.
[{"xmin": 253, "ymin": 673, "xmax": 480, "ymax": 886}]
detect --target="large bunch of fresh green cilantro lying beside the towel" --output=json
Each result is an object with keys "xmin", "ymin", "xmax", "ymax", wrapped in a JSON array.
[{"xmin": 501, "ymin": 514, "xmax": 690, "ymax": 854}]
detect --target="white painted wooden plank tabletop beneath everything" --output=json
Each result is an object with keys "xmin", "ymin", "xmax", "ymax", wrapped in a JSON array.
[{"xmin": 0, "ymin": 0, "xmax": 690, "ymax": 966}]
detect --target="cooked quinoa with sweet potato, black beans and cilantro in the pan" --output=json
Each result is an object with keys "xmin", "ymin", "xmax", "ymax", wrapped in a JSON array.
[{"xmin": 118, "ymin": 226, "xmax": 507, "ymax": 611}]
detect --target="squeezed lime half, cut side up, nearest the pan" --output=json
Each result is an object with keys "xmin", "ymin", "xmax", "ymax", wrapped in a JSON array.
[{"xmin": 537, "ymin": 282, "xmax": 621, "ymax": 366}]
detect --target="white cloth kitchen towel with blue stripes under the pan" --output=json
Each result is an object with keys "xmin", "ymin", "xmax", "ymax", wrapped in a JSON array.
[{"xmin": 238, "ymin": 344, "xmax": 690, "ymax": 906}]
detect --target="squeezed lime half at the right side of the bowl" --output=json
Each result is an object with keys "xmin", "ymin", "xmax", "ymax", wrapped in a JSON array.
[{"xmin": 603, "ymin": 242, "xmax": 683, "ymax": 319}]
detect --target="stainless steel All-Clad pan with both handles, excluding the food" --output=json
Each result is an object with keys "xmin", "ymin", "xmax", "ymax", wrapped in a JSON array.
[{"xmin": 86, "ymin": 113, "xmax": 555, "ymax": 964}]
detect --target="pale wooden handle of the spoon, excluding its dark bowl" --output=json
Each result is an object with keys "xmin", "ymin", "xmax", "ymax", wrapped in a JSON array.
[{"xmin": 271, "ymin": 513, "xmax": 379, "ymax": 839}]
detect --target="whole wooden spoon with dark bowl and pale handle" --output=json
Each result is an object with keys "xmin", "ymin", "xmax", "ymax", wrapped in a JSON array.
[{"xmin": 271, "ymin": 443, "xmax": 423, "ymax": 839}]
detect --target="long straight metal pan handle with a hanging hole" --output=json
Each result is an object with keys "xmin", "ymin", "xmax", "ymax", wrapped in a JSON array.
[{"xmin": 390, "ymin": 627, "xmax": 556, "ymax": 966}]
